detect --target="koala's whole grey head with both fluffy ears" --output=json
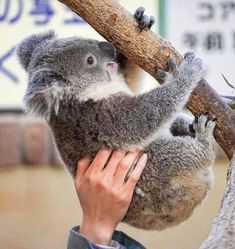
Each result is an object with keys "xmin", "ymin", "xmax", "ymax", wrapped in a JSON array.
[{"xmin": 16, "ymin": 32, "xmax": 117, "ymax": 119}]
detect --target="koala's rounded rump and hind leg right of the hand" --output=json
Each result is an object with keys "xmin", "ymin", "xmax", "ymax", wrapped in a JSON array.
[{"xmin": 125, "ymin": 115, "xmax": 215, "ymax": 230}]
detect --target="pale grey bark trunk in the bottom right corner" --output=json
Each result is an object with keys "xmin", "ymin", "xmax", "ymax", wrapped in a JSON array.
[{"xmin": 200, "ymin": 155, "xmax": 235, "ymax": 249}]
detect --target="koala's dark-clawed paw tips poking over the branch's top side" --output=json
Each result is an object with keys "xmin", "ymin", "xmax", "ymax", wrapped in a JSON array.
[{"xmin": 134, "ymin": 7, "xmax": 155, "ymax": 32}]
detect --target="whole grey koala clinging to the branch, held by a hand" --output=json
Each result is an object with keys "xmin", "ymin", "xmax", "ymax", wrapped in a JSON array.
[{"xmin": 17, "ymin": 8, "xmax": 215, "ymax": 230}]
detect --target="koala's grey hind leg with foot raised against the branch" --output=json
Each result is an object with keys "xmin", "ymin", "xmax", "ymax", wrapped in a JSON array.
[{"xmin": 144, "ymin": 114, "xmax": 215, "ymax": 179}]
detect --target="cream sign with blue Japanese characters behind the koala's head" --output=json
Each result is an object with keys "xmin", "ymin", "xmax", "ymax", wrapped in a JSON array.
[{"xmin": 0, "ymin": 0, "xmax": 156, "ymax": 109}]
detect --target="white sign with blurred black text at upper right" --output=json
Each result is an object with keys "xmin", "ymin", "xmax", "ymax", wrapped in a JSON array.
[{"xmin": 165, "ymin": 0, "xmax": 235, "ymax": 95}]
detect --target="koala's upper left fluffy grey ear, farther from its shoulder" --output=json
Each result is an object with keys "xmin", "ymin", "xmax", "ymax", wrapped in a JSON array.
[{"xmin": 16, "ymin": 31, "xmax": 55, "ymax": 70}]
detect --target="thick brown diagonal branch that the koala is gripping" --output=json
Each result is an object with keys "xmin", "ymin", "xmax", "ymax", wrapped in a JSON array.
[{"xmin": 59, "ymin": 0, "xmax": 235, "ymax": 159}]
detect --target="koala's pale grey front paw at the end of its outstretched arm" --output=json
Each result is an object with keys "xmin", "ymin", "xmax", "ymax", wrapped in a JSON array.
[{"xmin": 178, "ymin": 52, "xmax": 205, "ymax": 85}]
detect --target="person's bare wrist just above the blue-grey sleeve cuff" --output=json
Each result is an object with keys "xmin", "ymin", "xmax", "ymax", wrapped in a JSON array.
[{"xmin": 79, "ymin": 219, "xmax": 115, "ymax": 246}]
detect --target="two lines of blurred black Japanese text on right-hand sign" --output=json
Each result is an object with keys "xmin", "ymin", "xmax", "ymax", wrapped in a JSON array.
[{"xmin": 183, "ymin": 1, "xmax": 235, "ymax": 52}]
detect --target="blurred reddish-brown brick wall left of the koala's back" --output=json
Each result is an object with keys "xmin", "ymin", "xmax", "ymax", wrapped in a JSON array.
[{"xmin": 0, "ymin": 113, "xmax": 61, "ymax": 167}]
